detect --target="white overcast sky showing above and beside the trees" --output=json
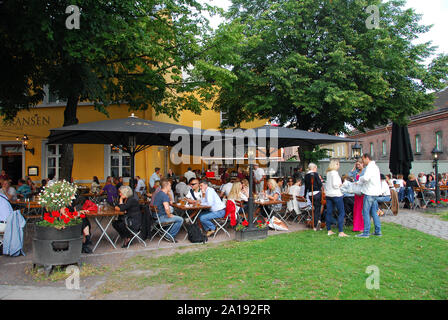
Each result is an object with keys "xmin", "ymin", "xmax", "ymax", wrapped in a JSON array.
[{"xmin": 202, "ymin": 0, "xmax": 448, "ymax": 54}]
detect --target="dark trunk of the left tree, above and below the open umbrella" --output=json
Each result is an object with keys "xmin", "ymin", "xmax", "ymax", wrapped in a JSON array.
[{"xmin": 59, "ymin": 95, "xmax": 79, "ymax": 181}]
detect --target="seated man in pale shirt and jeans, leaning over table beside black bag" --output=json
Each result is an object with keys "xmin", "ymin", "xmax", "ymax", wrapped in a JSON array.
[{"xmin": 199, "ymin": 180, "xmax": 226, "ymax": 237}]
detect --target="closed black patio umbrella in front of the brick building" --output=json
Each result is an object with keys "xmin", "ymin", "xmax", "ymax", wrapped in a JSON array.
[{"xmin": 389, "ymin": 123, "xmax": 414, "ymax": 179}]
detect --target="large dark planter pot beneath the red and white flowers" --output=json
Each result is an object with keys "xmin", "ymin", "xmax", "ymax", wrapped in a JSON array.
[{"xmin": 33, "ymin": 223, "xmax": 82, "ymax": 276}]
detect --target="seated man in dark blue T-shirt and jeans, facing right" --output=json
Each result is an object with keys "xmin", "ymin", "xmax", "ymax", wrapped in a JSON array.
[{"xmin": 154, "ymin": 179, "xmax": 184, "ymax": 242}]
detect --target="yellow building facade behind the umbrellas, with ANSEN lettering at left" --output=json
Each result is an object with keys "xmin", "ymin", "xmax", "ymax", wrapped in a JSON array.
[{"xmin": 0, "ymin": 97, "xmax": 266, "ymax": 184}]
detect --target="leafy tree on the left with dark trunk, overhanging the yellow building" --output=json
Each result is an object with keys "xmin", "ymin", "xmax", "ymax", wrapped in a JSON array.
[{"xmin": 0, "ymin": 0, "xmax": 228, "ymax": 179}]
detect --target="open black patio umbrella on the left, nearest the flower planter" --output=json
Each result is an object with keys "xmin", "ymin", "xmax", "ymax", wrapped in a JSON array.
[{"xmin": 48, "ymin": 114, "xmax": 218, "ymax": 186}]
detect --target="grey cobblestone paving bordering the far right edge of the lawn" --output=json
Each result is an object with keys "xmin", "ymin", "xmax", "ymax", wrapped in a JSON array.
[{"xmin": 381, "ymin": 209, "xmax": 448, "ymax": 240}]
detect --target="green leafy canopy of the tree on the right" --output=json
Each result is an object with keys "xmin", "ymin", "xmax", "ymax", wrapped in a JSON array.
[{"xmin": 210, "ymin": 0, "xmax": 448, "ymax": 134}]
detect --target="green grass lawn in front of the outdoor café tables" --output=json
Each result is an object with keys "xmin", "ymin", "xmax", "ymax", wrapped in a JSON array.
[{"xmin": 101, "ymin": 224, "xmax": 448, "ymax": 299}]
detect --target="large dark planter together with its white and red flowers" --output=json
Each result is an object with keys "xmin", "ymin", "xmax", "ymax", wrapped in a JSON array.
[{"xmin": 33, "ymin": 180, "xmax": 85, "ymax": 275}]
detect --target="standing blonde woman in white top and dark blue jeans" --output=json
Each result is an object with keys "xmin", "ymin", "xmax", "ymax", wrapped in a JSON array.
[{"xmin": 325, "ymin": 160, "xmax": 348, "ymax": 237}]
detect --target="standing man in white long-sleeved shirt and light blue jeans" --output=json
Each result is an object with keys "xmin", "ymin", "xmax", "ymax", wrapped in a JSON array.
[{"xmin": 357, "ymin": 153, "xmax": 382, "ymax": 238}]
